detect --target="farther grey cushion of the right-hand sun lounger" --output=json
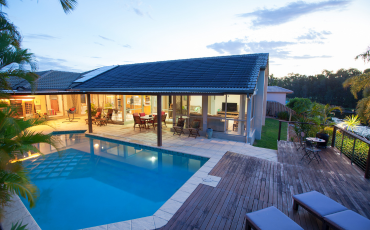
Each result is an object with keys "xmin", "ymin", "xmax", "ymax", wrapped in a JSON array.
[{"xmin": 293, "ymin": 191, "xmax": 347, "ymax": 217}]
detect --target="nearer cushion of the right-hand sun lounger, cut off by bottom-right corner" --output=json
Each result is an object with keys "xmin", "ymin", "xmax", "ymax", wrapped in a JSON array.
[{"xmin": 324, "ymin": 210, "xmax": 370, "ymax": 230}]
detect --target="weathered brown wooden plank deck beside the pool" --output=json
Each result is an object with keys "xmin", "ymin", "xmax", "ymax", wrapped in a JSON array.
[{"xmin": 162, "ymin": 141, "xmax": 370, "ymax": 229}]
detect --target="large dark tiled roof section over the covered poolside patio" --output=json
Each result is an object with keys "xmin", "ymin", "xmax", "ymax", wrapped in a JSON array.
[{"xmin": 73, "ymin": 53, "xmax": 268, "ymax": 93}]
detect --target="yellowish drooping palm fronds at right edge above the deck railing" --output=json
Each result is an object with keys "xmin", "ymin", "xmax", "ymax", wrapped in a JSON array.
[{"xmin": 343, "ymin": 47, "xmax": 370, "ymax": 122}]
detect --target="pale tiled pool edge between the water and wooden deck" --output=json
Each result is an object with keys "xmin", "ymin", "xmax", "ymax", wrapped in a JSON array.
[{"xmin": 83, "ymin": 133, "xmax": 226, "ymax": 230}]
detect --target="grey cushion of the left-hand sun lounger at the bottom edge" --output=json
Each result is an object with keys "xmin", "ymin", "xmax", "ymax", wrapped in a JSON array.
[{"xmin": 246, "ymin": 206, "xmax": 303, "ymax": 230}]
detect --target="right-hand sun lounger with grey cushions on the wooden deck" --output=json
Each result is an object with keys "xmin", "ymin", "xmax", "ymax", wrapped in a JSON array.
[{"xmin": 293, "ymin": 191, "xmax": 370, "ymax": 230}]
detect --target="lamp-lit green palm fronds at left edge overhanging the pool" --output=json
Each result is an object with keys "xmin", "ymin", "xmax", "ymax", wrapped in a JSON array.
[{"xmin": 0, "ymin": 104, "xmax": 57, "ymax": 214}]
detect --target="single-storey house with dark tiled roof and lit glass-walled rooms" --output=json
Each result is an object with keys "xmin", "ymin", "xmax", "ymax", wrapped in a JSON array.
[{"xmin": 5, "ymin": 53, "xmax": 269, "ymax": 146}]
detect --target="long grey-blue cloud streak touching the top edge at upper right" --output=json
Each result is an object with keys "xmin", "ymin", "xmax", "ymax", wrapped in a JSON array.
[{"xmin": 237, "ymin": 0, "xmax": 350, "ymax": 28}]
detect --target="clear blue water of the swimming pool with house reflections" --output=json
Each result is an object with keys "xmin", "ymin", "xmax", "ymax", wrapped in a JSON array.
[{"xmin": 23, "ymin": 134, "xmax": 208, "ymax": 230}]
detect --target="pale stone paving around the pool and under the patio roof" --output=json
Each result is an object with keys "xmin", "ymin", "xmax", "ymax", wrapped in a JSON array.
[{"xmin": 2, "ymin": 117, "xmax": 277, "ymax": 230}]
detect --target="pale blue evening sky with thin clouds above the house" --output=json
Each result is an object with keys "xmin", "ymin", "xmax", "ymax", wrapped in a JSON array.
[{"xmin": 3, "ymin": 0, "xmax": 370, "ymax": 77}]
